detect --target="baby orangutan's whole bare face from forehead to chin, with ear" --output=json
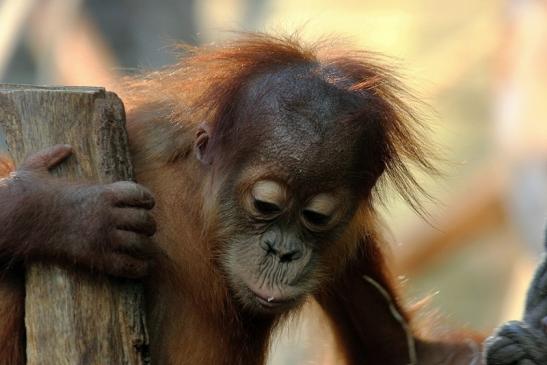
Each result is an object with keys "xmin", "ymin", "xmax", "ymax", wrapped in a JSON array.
[{"xmin": 197, "ymin": 68, "xmax": 382, "ymax": 312}]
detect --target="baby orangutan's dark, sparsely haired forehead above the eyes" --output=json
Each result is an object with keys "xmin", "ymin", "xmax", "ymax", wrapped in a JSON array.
[{"xmin": 234, "ymin": 65, "xmax": 382, "ymax": 193}]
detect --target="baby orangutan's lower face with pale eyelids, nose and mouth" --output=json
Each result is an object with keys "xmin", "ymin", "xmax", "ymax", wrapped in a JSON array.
[{"xmin": 216, "ymin": 168, "xmax": 353, "ymax": 312}]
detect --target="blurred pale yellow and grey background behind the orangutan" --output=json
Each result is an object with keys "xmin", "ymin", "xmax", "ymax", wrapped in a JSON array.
[{"xmin": 0, "ymin": 0, "xmax": 547, "ymax": 365}]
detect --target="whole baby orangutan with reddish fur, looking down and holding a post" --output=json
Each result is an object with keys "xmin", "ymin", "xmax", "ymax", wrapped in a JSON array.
[{"xmin": 0, "ymin": 34, "xmax": 547, "ymax": 365}]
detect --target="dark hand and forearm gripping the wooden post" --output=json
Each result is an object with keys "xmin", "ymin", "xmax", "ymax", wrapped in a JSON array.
[{"xmin": 0, "ymin": 145, "xmax": 156, "ymax": 278}]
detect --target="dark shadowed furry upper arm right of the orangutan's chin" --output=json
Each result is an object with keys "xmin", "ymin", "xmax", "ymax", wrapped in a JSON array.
[{"xmin": 317, "ymin": 232, "xmax": 409, "ymax": 365}]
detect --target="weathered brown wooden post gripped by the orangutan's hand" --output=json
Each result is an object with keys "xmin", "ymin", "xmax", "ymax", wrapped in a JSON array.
[{"xmin": 0, "ymin": 84, "xmax": 150, "ymax": 365}]
